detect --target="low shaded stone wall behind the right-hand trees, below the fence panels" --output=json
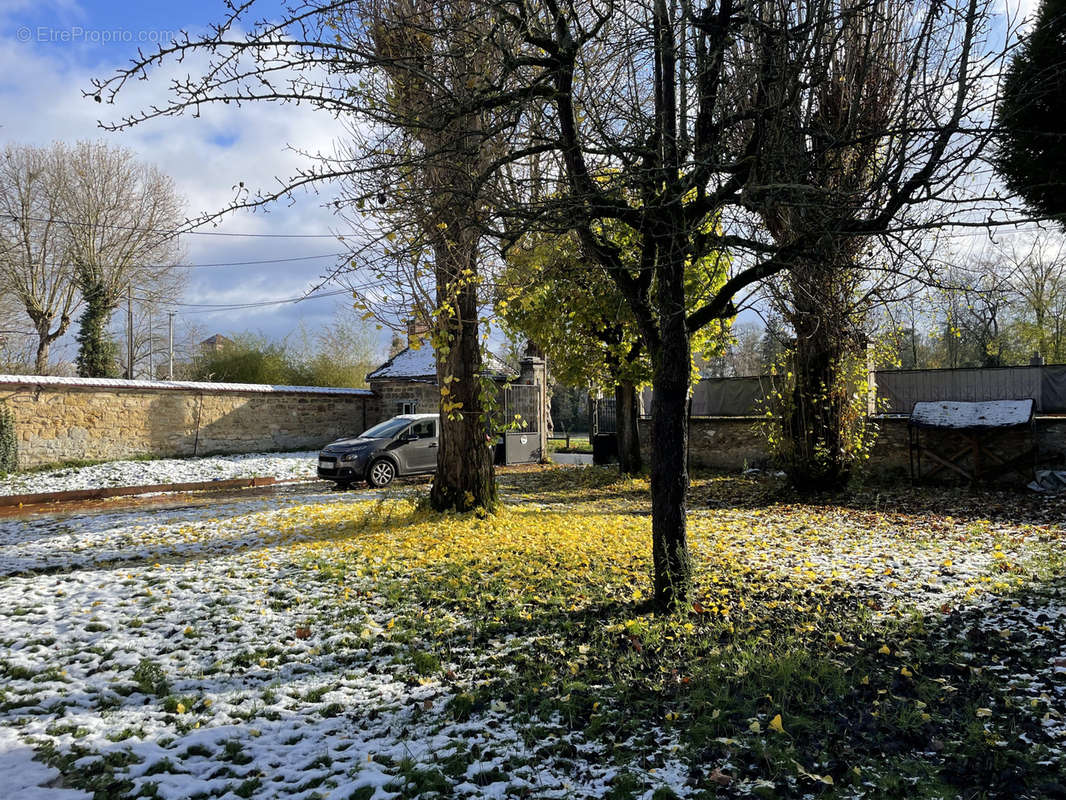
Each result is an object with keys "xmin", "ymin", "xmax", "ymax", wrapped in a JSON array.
[{"xmin": 640, "ymin": 416, "xmax": 1066, "ymax": 480}]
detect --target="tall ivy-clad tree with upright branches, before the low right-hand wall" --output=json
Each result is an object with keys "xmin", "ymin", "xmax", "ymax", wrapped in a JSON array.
[{"xmin": 747, "ymin": 0, "xmax": 912, "ymax": 491}]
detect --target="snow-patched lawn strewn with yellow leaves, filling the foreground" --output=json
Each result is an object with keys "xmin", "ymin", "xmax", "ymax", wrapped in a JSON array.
[{"xmin": 0, "ymin": 468, "xmax": 1066, "ymax": 800}]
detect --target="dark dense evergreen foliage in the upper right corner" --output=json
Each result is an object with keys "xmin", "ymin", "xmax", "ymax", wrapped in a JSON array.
[{"xmin": 995, "ymin": 0, "xmax": 1066, "ymax": 224}]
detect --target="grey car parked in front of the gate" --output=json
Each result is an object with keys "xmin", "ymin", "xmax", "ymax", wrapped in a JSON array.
[{"xmin": 319, "ymin": 414, "xmax": 439, "ymax": 489}]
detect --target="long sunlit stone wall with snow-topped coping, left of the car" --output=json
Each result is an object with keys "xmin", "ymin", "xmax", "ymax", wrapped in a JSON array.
[{"xmin": 0, "ymin": 375, "xmax": 381, "ymax": 469}]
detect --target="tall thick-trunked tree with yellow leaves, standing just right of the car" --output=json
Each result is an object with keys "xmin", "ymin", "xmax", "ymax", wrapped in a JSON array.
[{"xmin": 360, "ymin": 0, "xmax": 505, "ymax": 511}]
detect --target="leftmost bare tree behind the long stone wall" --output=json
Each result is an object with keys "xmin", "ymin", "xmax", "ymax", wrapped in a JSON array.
[{"xmin": 0, "ymin": 145, "xmax": 79, "ymax": 374}]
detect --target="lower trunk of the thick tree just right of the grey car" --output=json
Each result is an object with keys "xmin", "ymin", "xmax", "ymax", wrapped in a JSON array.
[{"xmin": 430, "ymin": 230, "xmax": 496, "ymax": 511}]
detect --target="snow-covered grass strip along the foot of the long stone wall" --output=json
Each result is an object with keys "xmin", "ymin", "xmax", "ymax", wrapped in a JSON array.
[{"xmin": 0, "ymin": 452, "xmax": 318, "ymax": 495}]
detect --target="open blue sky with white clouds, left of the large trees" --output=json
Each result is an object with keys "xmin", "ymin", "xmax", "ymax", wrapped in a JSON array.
[{"xmin": 0, "ymin": 0, "xmax": 366, "ymax": 358}]
